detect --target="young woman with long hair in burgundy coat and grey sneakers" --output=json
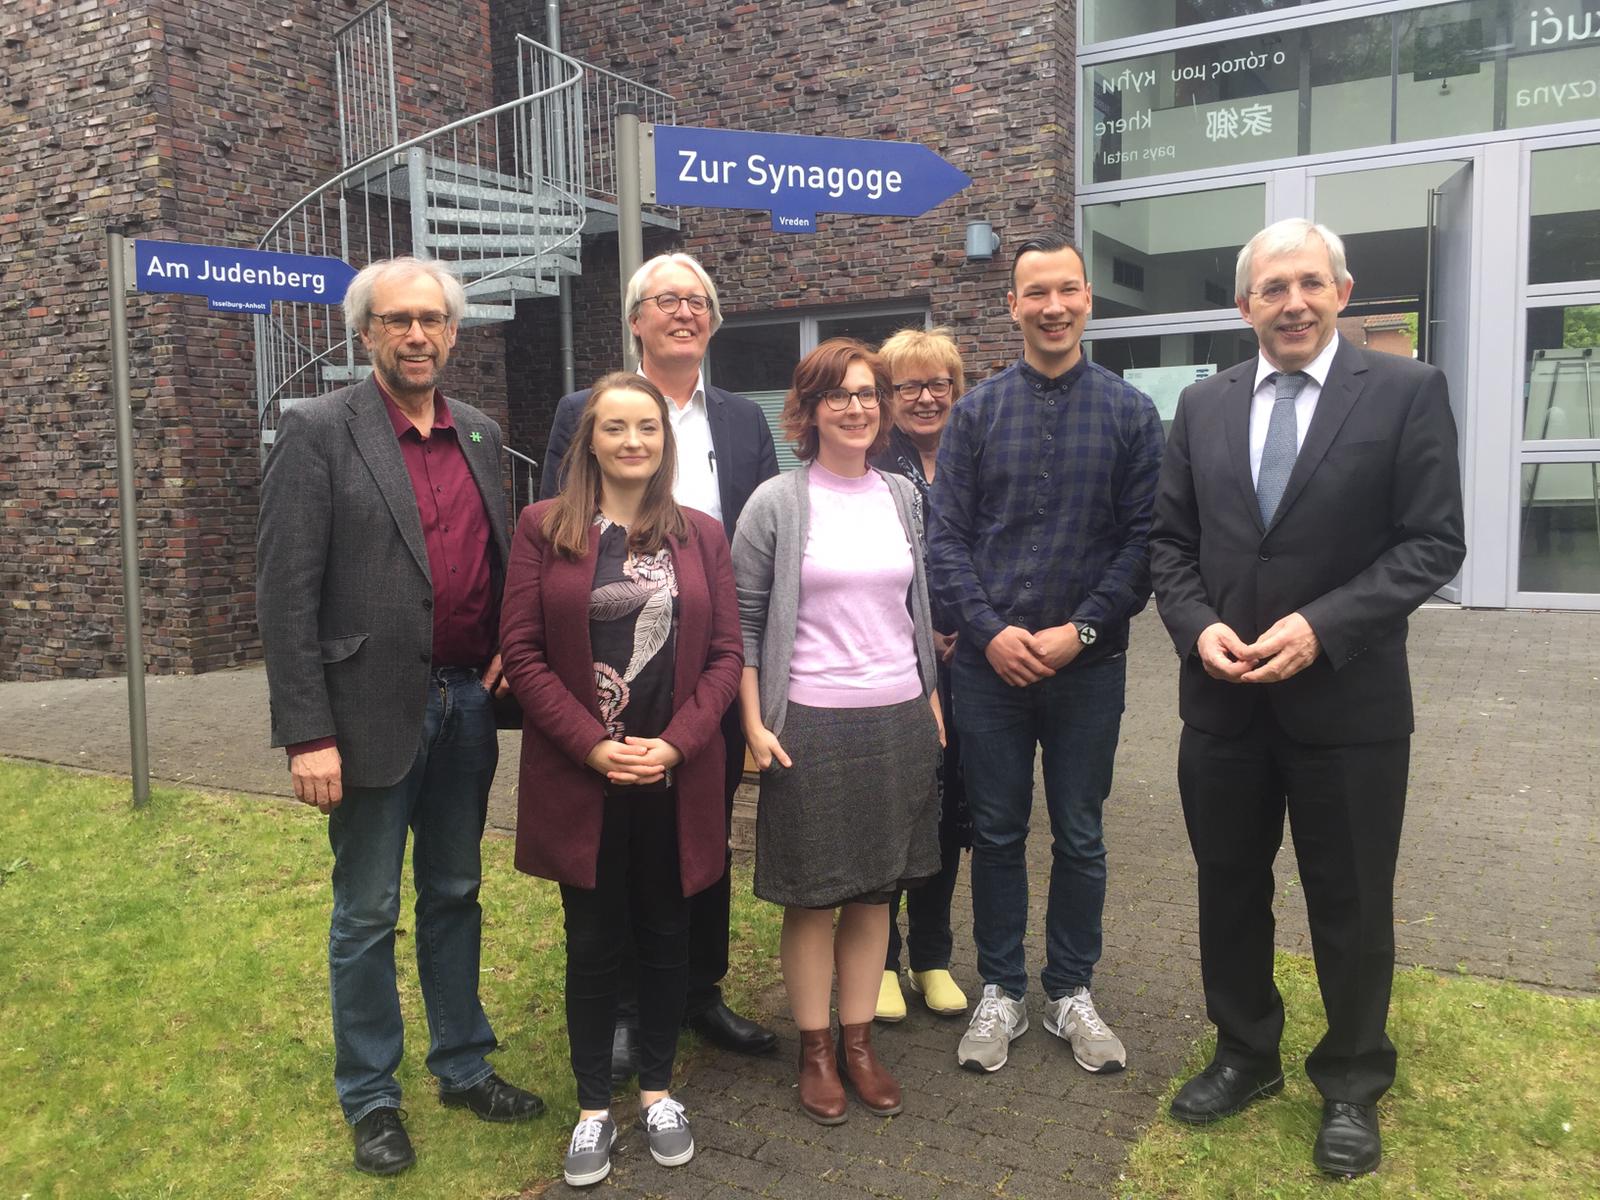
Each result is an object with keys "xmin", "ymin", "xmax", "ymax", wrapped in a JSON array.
[{"xmin": 501, "ymin": 373, "xmax": 742, "ymax": 1186}]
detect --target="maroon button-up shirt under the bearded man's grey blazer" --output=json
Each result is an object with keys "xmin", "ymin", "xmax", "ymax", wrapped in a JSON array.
[{"xmin": 283, "ymin": 381, "xmax": 499, "ymax": 758}]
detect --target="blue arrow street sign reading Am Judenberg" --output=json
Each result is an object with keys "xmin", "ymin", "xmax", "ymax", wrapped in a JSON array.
[{"xmin": 133, "ymin": 240, "xmax": 355, "ymax": 312}]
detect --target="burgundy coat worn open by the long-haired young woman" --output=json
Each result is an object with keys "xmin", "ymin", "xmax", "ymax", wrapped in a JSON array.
[{"xmin": 501, "ymin": 501, "xmax": 744, "ymax": 896}]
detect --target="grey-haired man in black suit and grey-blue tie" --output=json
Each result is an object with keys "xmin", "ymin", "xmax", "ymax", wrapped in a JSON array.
[{"xmin": 1150, "ymin": 219, "xmax": 1466, "ymax": 1176}]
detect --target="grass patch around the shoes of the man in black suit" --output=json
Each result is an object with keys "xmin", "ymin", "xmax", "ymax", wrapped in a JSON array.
[{"xmin": 1120, "ymin": 954, "xmax": 1600, "ymax": 1200}]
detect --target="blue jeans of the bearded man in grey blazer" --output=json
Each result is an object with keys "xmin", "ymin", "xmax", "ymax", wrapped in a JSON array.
[{"xmin": 328, "ymin": 667, "xmax": 499, "ymax": 1125}]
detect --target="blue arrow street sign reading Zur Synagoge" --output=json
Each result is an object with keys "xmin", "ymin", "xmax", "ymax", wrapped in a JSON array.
[{"xmin": 654, "ymin": 125, "xmax": 971, "ymax": 234}]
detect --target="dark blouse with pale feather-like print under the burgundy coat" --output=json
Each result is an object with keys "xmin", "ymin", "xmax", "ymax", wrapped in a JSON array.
[{"xmin": 589, "ymin": 517, "xmax": 678, "ymax": 795}]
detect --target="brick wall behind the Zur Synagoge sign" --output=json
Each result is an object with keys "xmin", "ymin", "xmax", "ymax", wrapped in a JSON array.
[{"xmin": 496, "ymin": 0, "xmax": 1075, "ymax": 470}]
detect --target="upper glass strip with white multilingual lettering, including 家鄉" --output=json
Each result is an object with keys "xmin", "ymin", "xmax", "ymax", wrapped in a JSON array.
[{"xmin": 1083, "ymin": 0, "xmax": 1600, "ymax": 182}]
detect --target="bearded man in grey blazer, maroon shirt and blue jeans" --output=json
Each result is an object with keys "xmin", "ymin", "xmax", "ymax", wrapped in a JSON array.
[{"xmin": 256, "ymin": 259, "xmax": 544, "ymax": 1174}]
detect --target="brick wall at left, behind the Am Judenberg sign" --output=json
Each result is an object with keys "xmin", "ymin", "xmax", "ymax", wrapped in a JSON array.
[{"xmin": 0, "ymin": 0, "xmax": 506, "ymax": 678}]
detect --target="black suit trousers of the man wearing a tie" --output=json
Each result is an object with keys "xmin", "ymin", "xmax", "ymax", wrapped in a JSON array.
[{"xmin": 1178, "ymin": 704, "xmax": 1411, "ymax": 1104}]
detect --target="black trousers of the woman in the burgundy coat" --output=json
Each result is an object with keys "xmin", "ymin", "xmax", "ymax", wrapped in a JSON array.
[{"xmin": 562, "ymin": 792, "xmax": 690, "ymax": 1109}]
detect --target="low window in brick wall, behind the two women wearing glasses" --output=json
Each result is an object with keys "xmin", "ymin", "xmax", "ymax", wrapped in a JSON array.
[{"xmin": 706, "ymin": 307, "xmax": 928, "ymax": 470}]
